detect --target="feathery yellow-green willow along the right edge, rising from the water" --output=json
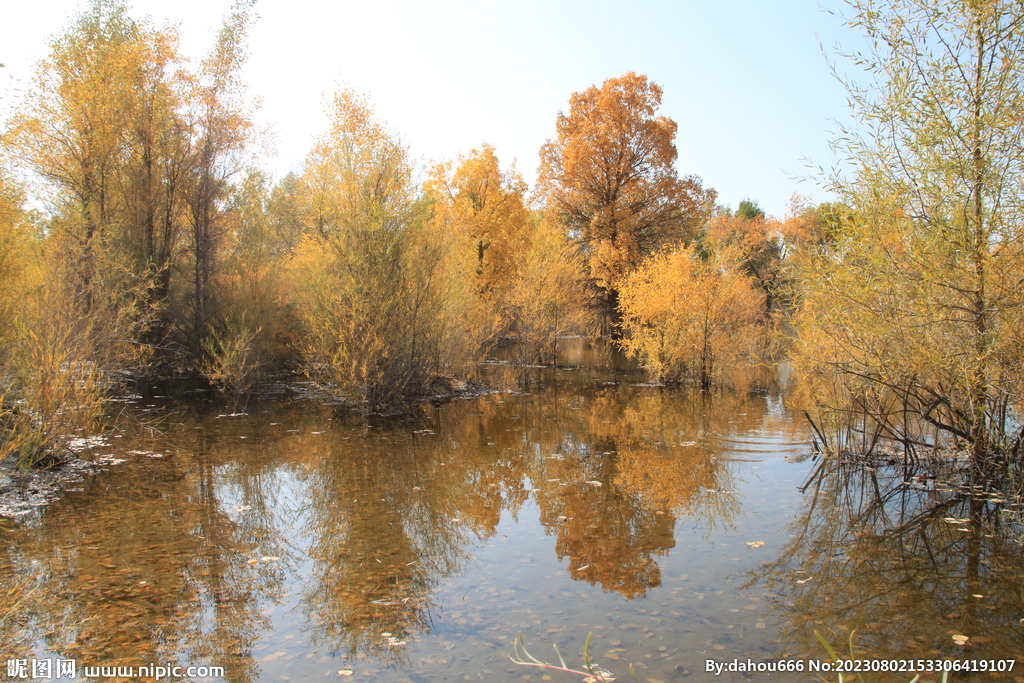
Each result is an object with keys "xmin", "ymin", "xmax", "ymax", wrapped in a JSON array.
[{"xmin": 800, "ymin": 0, "xmax": 1024, "ymax": 463}]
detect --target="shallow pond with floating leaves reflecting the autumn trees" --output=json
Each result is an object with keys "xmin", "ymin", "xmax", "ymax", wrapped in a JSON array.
[{"xmin": 0, "ymin": 356, "xmax": 1024, "ymax": 683}]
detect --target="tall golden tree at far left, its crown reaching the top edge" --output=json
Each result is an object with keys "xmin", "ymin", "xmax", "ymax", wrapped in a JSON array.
[{"xmin": 4, "ymin": 0, "xmax": 187, "ymax": 315}]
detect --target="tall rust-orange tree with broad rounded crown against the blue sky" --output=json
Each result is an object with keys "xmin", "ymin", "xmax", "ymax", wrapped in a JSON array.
[{"xmin": 538, "ymin": 73, "xmax": 715, "ymax": 331}]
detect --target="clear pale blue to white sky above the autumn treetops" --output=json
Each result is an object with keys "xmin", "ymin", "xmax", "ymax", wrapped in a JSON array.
[{"xmin": 0, "ymin": 0, "xmax": 858, "ymax": 216}]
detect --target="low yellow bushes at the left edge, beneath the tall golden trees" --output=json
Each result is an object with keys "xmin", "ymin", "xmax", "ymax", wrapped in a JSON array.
[{"xmin": 0, "ymin": 171, "xmax": 148, "ymax": 466}]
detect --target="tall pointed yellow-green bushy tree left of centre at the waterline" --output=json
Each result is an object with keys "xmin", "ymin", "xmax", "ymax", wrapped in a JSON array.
[{"xmin": 297, "ymin": 91, "xmax": 489, "ymax": 411}]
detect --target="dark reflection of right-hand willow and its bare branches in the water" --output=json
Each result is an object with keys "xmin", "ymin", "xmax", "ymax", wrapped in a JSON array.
[{"xmin": 750, "ymin": 461, "xmax": 1024, "ymax": 678}]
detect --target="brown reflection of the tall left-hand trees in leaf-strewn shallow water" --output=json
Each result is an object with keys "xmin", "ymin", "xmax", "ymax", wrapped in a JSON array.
[{"xmin": 0, "ymin": 417, "xmax": 289, "ymax": 683}]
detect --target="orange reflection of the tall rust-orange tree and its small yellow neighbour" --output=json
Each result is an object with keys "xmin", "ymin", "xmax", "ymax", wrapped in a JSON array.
[{"xmin": 534, "ymin": 389, "xmax": 749, "ymax": 598}]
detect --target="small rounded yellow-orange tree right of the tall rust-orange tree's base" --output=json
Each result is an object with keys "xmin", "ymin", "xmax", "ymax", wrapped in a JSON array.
[{"xmin": 620, "ymin": 247, "xmax": 764, "ymax": 387}]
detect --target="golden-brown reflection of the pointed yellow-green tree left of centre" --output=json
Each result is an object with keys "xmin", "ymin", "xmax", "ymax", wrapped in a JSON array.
[{"xmin": 302, "ymin": 417, "xmax": 522, "ymax": 664}]
